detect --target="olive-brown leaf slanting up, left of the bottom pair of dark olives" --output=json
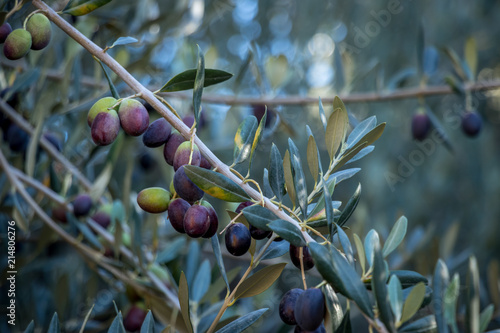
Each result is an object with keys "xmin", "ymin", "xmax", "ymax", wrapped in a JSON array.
[{"xmin": 234, "ymin": 263, "xmax": 286, "ymax": 299}]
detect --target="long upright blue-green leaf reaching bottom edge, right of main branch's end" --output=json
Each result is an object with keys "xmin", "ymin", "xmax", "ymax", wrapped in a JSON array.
[{"xmin": 372, "ymin": 244, "xmax": 396, "ymax": 333}]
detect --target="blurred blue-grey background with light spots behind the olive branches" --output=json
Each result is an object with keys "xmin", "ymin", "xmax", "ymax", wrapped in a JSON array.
[{"xmin": 0, "ymin": 0, "xmax": 500, "ymax": 332}]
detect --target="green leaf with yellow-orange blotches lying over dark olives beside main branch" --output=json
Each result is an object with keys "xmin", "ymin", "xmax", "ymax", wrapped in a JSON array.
[{"xmin": 184, "ymin": 165, "xmax": 250, "ymax": 202}]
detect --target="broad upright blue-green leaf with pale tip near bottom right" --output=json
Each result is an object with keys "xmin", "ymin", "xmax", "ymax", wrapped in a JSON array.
[{"xmin": 434, "ymin": 259, "xmax": 450, "ymax": 333}]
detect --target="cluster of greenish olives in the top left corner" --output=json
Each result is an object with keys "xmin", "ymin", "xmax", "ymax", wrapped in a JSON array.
[{"xmin": 0, "ymin": 13, "xmax": 52, "ymax": 60}]
